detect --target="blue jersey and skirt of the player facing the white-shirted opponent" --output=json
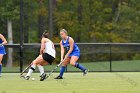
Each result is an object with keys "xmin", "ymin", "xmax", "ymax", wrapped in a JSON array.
[{"xmin": 62, "ymin": 36, "xmax": 80, "ymax": 57}]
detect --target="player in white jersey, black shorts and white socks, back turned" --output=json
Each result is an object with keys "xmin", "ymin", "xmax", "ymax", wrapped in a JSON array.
[{"xmin": 22, "ymin": 32, "xmax": 56, "ymax": 81}]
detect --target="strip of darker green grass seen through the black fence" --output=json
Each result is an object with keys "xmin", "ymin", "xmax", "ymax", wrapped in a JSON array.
[{"xmin": 3, "ymin": 60, "xmax": 140, "ymax": 72}]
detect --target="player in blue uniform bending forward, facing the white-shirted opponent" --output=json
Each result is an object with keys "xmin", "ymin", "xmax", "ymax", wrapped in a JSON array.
[{"xmin": 55, "ymin": 29, "xmax": 88, "ymax": 79}]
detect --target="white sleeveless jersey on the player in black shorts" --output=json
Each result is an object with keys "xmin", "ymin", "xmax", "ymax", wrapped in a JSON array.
[{"xmin": 44, "ymin": 41, "xmax": 56, "ymax": 58}]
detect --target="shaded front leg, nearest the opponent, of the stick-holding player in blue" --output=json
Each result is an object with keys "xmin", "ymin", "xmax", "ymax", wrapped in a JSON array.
[{"xmin": 54, "ymin": 57, "xmax": 70, "ymax": 79}]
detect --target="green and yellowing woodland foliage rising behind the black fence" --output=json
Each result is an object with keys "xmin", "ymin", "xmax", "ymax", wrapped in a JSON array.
[{"xmin": 0, "ymin": 0, "xmax": 140, "ymax": 62}]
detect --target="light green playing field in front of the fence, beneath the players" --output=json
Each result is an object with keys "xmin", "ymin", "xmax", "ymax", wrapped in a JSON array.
[{"xmin": 0, "ymin": 72, "xmax": 140, "ymax": 93}]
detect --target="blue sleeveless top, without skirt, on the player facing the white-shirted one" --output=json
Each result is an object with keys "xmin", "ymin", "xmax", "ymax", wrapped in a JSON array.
[{"xmin": 62, "ymin": 36, "xmax": 80, "ymax": 53}]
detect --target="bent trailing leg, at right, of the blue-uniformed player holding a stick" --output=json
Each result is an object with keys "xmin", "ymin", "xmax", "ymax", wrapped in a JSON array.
[{"xmin": 70, "ymin": 56, "xmax": 87, "ymax": 75}]
